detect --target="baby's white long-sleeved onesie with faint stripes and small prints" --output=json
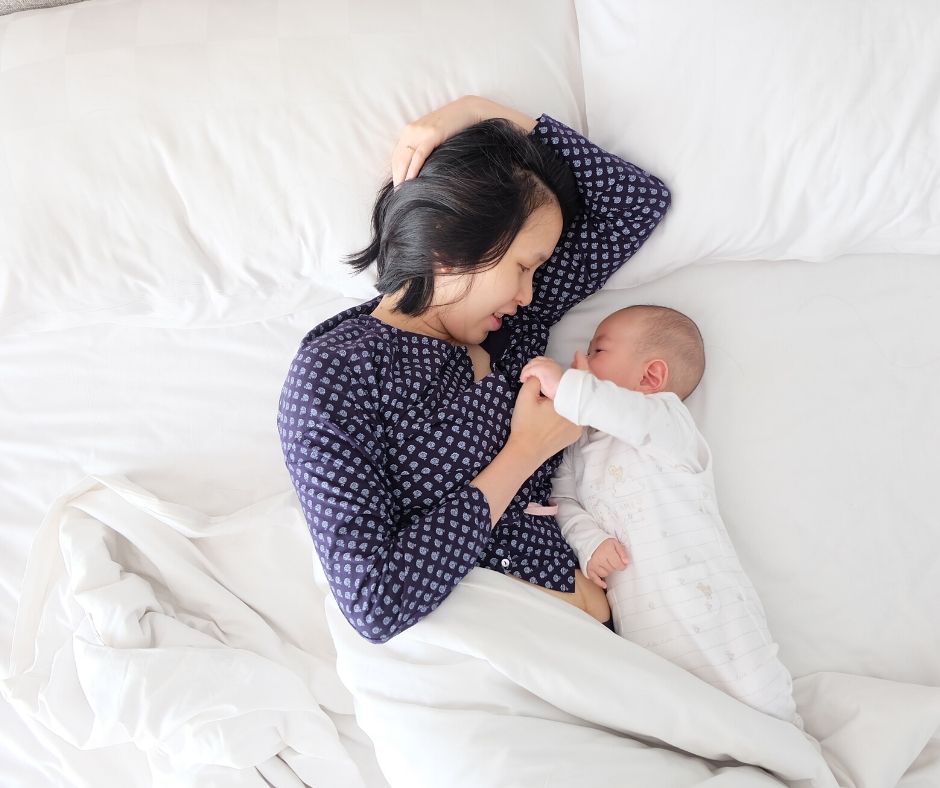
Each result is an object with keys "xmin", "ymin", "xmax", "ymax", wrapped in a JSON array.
[{"xmin": 552, "ymin": 369, "xmax": 801, "ymax": 725}]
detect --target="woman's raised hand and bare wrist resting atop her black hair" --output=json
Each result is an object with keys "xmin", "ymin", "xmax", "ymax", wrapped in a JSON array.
[{"xmin": 392, "ymin": 96, "xmax": 535, "ymax": 186}]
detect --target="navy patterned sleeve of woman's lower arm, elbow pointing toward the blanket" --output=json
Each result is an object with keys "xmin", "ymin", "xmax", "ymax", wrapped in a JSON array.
[{"xmin": 278, "ymin": 342, "xmax": 490, "ymax": 643}]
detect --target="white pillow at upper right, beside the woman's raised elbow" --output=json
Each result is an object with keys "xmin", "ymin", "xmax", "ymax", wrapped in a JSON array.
[{"xmin": 577, "ymin": 0, "xmax": 940, "ymax": 286}]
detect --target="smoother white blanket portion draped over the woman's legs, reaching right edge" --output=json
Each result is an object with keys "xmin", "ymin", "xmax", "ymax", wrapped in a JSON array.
[{"xmin": 327, "ymin": 569, "xmax": 940, "ymax": 788}]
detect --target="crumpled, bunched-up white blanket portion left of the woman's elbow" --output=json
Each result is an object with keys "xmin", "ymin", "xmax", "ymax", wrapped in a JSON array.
[{"xmin": 0, "ymin": 477, "xmax": 384, "ymax": 788}]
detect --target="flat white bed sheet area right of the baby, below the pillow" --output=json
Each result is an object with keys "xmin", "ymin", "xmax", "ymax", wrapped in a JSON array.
[{"xmin": 549, "ymin": 255, "xmax": 940, "ymax": 686}]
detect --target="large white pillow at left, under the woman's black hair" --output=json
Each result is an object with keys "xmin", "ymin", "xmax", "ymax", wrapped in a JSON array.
[{"xmin": 0, "ymin": 0, "xmax": 583, "ymax": 335}]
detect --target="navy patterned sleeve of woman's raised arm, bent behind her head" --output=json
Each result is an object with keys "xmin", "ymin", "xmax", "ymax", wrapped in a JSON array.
[{"xmin": 528, "ymin": 115, "xmax": 670, "ymax": 326}]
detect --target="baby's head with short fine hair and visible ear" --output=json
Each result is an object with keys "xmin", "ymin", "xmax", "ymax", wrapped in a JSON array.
[{"xmin": 587, "ymin": 306, "xmax": 705, "ymax": 399}]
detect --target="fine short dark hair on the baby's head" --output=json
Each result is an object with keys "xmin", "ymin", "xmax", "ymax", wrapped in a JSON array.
[{"xmin": 619, "ymin": 304, "xmax": 705, "ymax": 399}]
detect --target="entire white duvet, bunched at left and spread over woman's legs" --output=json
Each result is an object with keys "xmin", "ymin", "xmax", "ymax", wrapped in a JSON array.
[{"xmin": 3, "ymin": 477, "xmax": 940, "ymax": 788}]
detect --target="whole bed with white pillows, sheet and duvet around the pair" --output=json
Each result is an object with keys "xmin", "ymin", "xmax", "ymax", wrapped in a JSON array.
[{"xmin": 0, "ymin": 0, "xmax": 940, "ymax": 788}]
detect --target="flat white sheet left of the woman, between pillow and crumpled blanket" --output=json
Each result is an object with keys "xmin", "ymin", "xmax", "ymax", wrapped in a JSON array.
[{"xmin": 0, "ymin": 295, "xmax": 364, "ymax": 788}]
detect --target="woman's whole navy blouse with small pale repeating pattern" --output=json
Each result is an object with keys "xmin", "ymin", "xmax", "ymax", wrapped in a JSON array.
[{"xmin": 278, "ymin": 115, "xmax": 670, "ymax": 643}]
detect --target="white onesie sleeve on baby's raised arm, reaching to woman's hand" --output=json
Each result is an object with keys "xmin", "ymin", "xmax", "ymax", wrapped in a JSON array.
[{"xmin": 555, "ymin": 369, "xmax": 707, "ymax": 470}]
